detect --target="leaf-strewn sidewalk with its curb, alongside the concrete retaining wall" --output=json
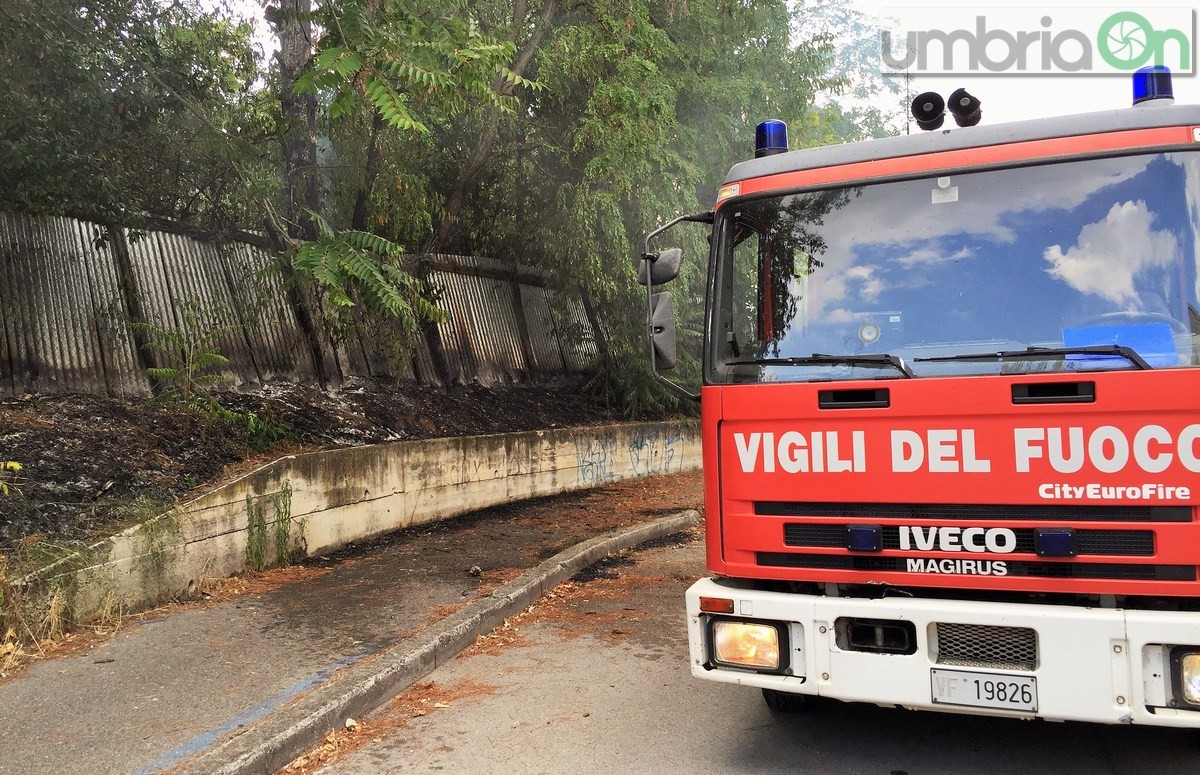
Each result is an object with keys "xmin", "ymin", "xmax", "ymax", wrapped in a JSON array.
[{"xmin": 0, "ymin": 473, "xmax": 702, "ymax": 775}]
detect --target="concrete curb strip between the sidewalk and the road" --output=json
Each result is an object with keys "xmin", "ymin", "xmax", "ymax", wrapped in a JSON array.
[{"xmin": 170, "ymin": 511, "xmax": 700, "ymax": 775}]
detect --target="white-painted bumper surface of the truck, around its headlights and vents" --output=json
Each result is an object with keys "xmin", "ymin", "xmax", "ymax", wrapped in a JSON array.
[{"xmin": 688, "ymin": 578, "xmax": 1200, "ymax": 728}]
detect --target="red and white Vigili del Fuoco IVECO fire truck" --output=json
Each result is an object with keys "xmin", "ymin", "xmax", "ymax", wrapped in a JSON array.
[{"xmin": 640, "ymin": 70, "xmax": 1200, "ymax": 727}]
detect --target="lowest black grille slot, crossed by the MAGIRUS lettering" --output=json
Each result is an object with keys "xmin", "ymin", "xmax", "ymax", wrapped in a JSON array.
[{"xmin": 756, "ymin": 552, "xmax": 1196, "ymax": 582}]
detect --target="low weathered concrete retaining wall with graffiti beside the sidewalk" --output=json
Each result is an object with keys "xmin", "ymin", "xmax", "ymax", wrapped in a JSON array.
[{"xmin": 42, "ymin": 422, "xmax": 701, "ymax": 621}]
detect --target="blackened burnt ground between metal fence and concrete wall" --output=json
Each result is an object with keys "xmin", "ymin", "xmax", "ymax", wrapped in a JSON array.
[{"xmin": 0, "ymin": 378, "xmax": 648, "ymax": 553}]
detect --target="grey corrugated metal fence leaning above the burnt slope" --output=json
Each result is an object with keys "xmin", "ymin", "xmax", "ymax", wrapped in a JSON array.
[{"xmin": 0, "ymin": 214, "xmax": 598, "ymax": 396}]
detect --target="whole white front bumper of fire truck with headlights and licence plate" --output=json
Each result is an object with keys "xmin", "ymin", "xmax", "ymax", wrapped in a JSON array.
[{"xmin": 686, "ymin": 578, "xmax": 1200, "ymax": 727}]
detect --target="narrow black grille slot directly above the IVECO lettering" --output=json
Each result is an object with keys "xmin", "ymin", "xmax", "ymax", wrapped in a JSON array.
[{"xmin": 754, "ymin": 501, "xmax": 1192, "ymax": 524}]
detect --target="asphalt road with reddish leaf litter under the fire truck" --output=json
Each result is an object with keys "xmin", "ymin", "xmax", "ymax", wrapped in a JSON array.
[{"xmin": 309, "ymin": 540, "xmax": 1200, "ymax": 775}]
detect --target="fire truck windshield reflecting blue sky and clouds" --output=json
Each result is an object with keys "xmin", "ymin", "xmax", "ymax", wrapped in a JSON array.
[{"xmin": 707, "ymin": 152, "xmax": 1200, "ymax": 383}]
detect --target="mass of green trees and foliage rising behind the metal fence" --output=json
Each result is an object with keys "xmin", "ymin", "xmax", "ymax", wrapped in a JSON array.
[{"xmin": 7, "ymin": 0, "xmax": 895, "ymax": 419}]
